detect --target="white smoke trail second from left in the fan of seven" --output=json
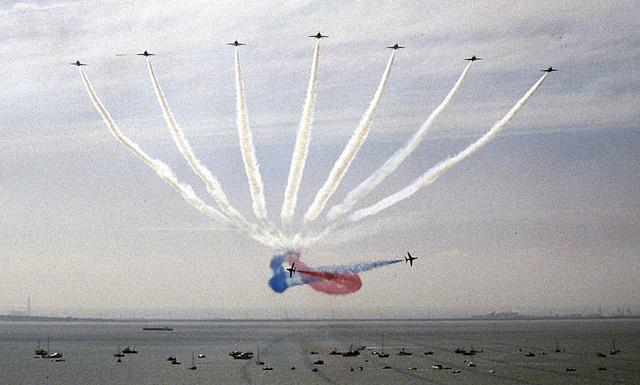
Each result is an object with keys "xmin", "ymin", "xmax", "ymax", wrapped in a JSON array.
[{"xmin": 147, "ymin": 58, "xmax": 251, "ymax": 229}]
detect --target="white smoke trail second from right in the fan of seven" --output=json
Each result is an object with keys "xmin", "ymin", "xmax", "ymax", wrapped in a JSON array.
[{"xmin": 327, "ymin": 62, "xmax": 472, "ymax": 221}]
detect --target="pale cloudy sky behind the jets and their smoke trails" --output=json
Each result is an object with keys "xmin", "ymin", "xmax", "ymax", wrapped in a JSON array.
[{"xmin": 0, "ymin": 1, "xmax": 640, "ymax": 317}]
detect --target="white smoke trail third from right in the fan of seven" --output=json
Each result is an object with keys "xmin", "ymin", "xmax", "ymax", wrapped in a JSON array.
[{"xmin": 304, "ymin": 50, "xmax": 396, "ymax": 224}]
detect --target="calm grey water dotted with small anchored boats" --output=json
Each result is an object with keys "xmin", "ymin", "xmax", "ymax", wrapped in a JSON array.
[{"xmin": 0, "ymin": 320, "xmax": 640, "ymax": 385}]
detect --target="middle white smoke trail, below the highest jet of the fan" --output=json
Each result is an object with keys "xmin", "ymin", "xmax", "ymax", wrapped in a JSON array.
[{"xmin": 280, "ymin": 39, "xmax": 320, "ymax": 225}]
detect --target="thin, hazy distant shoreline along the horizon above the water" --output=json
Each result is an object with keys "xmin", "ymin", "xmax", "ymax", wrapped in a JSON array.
[{"xmin": 0, "ymin": 314, "xmax": 640, "ymax": 324}]
